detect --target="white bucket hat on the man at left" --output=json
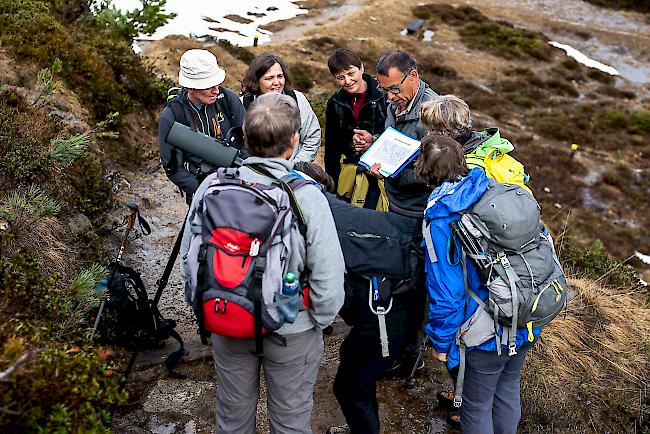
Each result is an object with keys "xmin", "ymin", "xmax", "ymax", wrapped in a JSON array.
[{"xmin": 178, "ymin": 50, "xmax": 226, "ymax": 89}]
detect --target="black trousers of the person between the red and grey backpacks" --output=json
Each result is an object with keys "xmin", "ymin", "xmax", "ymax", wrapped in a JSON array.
[{"xmin": 334, "ymin": 276, "xmax": 424, "ymax": 434}]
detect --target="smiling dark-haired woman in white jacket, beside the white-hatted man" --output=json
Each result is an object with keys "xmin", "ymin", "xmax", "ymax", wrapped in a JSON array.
[{"xmin": 241, "ymin": 53, "xmax": 321, "ymax": 162}]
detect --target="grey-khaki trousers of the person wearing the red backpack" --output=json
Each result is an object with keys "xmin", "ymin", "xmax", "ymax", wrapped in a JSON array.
[{"xmin": 212, "ymin": 328, "xmax": 323, "ymax": 434}]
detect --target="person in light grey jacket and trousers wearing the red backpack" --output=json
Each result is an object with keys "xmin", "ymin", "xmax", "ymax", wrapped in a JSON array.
[{"xmin": 190, "ymin": 93, "xmax": 345, "ymax": 434}]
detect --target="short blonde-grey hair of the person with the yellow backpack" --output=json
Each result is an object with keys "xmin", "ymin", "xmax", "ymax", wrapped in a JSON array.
[{"xmin": 420, "ymin": 95, "xmax": 472, "ymax": 138}]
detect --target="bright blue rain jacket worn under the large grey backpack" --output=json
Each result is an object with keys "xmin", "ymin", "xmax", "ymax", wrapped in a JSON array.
[{"xmin": 424, "ymin": 168, "xmax": 541, "ymax": 369}]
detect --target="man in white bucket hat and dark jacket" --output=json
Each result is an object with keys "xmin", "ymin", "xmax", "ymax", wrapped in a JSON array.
[{"xmin": 158, "ymin": 50, "xmax": 246, "ymax": 204}]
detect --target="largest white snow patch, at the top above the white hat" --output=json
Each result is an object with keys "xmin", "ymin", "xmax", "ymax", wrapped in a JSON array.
[{"xmin": 105, "ymin": 0, "xmax": 307, "ymax": 46}]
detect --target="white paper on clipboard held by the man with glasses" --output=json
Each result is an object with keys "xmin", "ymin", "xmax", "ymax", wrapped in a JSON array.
[{"xmin": 359, "ymin": 127, "xmax": 420, "ymax": 176}]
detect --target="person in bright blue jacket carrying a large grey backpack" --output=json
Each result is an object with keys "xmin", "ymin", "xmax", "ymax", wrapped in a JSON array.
[{"xmin": 416, "ymin": 134, "xmax": 541, "ymax": 434}]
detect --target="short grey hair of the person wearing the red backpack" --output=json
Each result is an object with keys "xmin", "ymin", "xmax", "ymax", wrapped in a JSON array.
[{"xmin": 244, "ymin": 92, "xmax": 300, "ymax": 157}]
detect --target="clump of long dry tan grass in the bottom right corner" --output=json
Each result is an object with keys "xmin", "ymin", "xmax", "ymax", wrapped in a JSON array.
[{"xmin": 522, "ymin": 280, "xmax": 650, "ymax": 432}]
